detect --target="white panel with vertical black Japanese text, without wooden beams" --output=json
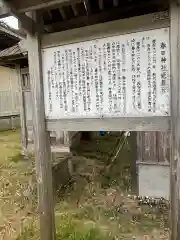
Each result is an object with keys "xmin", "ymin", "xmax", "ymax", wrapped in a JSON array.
[{"xmin": 42, "ymin": 28, "xmax": 170, "ymax": 119}]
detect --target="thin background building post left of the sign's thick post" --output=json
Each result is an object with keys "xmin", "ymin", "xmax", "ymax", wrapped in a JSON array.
[{"xmin": 16, "ymin": 65, "xmax": 28, "ymax": 154}]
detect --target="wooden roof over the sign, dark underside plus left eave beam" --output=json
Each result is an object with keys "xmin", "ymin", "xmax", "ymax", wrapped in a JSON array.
[{"xmin": 0, "ymin": 0, "xmax": 169, "ymax": 32}]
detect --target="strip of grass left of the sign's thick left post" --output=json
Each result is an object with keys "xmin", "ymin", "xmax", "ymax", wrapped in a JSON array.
[{"xmin": 0, "ymin": 131, "xmax": 36, "ymax": 240}]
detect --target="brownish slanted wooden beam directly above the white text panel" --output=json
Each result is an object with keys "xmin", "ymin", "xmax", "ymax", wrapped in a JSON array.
[{"xmin": 42, "ymin": 12, "xmax": 169, "ymax": 48}]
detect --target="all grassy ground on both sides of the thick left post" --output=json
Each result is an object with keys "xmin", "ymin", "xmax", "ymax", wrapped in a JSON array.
[{"xmin": 0, "ymin": 131, "xmax": 169, "ymax": 240}]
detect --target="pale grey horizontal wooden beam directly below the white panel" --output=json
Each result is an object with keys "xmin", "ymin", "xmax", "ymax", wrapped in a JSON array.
[{"xmin": 47, "ymin": 117, "xmax": 170, "ymax": 132}]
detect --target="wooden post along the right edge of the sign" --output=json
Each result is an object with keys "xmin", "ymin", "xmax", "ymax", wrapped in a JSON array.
[{"xmin": 170, "ymin": 0, "xmax": 180, "ymax": 240}]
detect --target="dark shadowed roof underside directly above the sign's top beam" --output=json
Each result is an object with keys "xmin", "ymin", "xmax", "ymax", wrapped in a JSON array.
[{"xmin": 43, "ymin": 0, "xmax": 168, "ymax": 32}]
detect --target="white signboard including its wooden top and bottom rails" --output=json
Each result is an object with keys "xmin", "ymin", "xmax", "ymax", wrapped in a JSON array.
[{"xmin": 42, "ymin": 13, "xmax": 170, "ymax": 131}]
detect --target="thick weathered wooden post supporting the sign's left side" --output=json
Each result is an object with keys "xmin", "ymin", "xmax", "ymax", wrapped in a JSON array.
[{"xmin": 27, "ymin": 12, "xmax": 55, "ymax": 240}]
